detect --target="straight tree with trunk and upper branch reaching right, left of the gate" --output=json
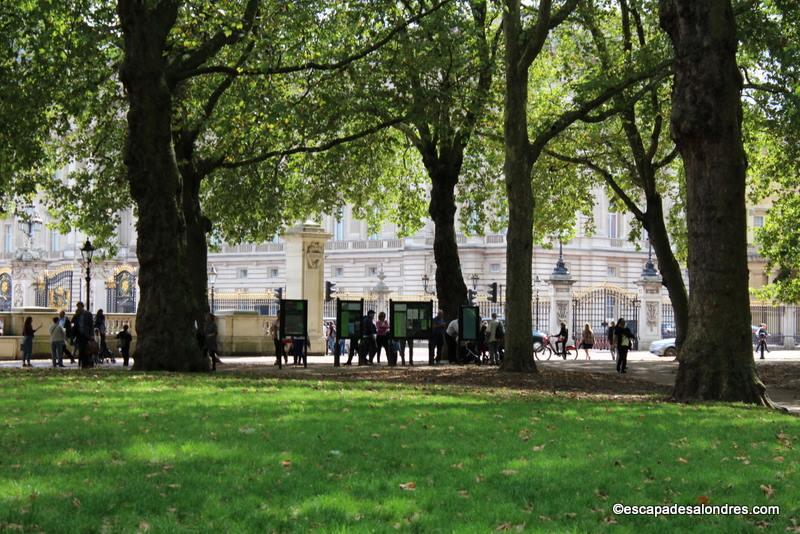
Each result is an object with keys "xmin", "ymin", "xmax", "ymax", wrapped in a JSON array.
[{"xmin": 502, "ymin": 0, "xmax": 662, "ymax": 371}]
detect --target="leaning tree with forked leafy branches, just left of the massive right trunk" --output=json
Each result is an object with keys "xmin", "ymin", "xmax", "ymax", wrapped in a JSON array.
[{"xmin": 546, "ymin": 0, "xmax": 689, "ymax": 347}]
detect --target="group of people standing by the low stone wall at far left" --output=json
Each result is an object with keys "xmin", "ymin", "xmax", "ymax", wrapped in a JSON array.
[{"xmin": 22, "ymin": 302, "xmax": 132, "ymax": 368}]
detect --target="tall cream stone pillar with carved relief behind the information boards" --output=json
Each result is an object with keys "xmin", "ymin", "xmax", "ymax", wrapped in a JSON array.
[{"xmin": 283, "ymin": 221, "xmax": 332, "ymax": 354}]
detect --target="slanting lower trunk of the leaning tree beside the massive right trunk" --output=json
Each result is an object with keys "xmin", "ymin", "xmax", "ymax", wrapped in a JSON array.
[{"xmin": 644, "ymin": 193, "xmax": 689, "ymax": 350}]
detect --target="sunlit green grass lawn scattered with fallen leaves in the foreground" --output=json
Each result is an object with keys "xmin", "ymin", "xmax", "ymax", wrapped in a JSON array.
[{"xmin": 0, "ymin": 370, "xmax": 800, "ymax": 532}]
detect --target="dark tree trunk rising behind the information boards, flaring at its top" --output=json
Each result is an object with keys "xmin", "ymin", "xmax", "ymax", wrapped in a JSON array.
[{"xmin": 426, "ymin": 158, "xmax": 467, "ymax": 328}]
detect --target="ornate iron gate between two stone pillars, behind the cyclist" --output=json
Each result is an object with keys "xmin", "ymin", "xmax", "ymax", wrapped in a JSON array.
[{"xmin": 572, "ymin": 285, "xmax": 640, "ymax": 349}]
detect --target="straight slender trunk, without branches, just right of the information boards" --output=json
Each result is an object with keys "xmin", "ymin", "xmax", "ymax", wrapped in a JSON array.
[{"xmin": 502, "ymin": 2, "xmax": 536, "ymax": 371}]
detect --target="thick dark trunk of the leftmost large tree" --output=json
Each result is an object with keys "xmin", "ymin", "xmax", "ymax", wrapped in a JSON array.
[{"xmin": 117, "ymin": 0, "xmax": 209, "ymax": 371}]
